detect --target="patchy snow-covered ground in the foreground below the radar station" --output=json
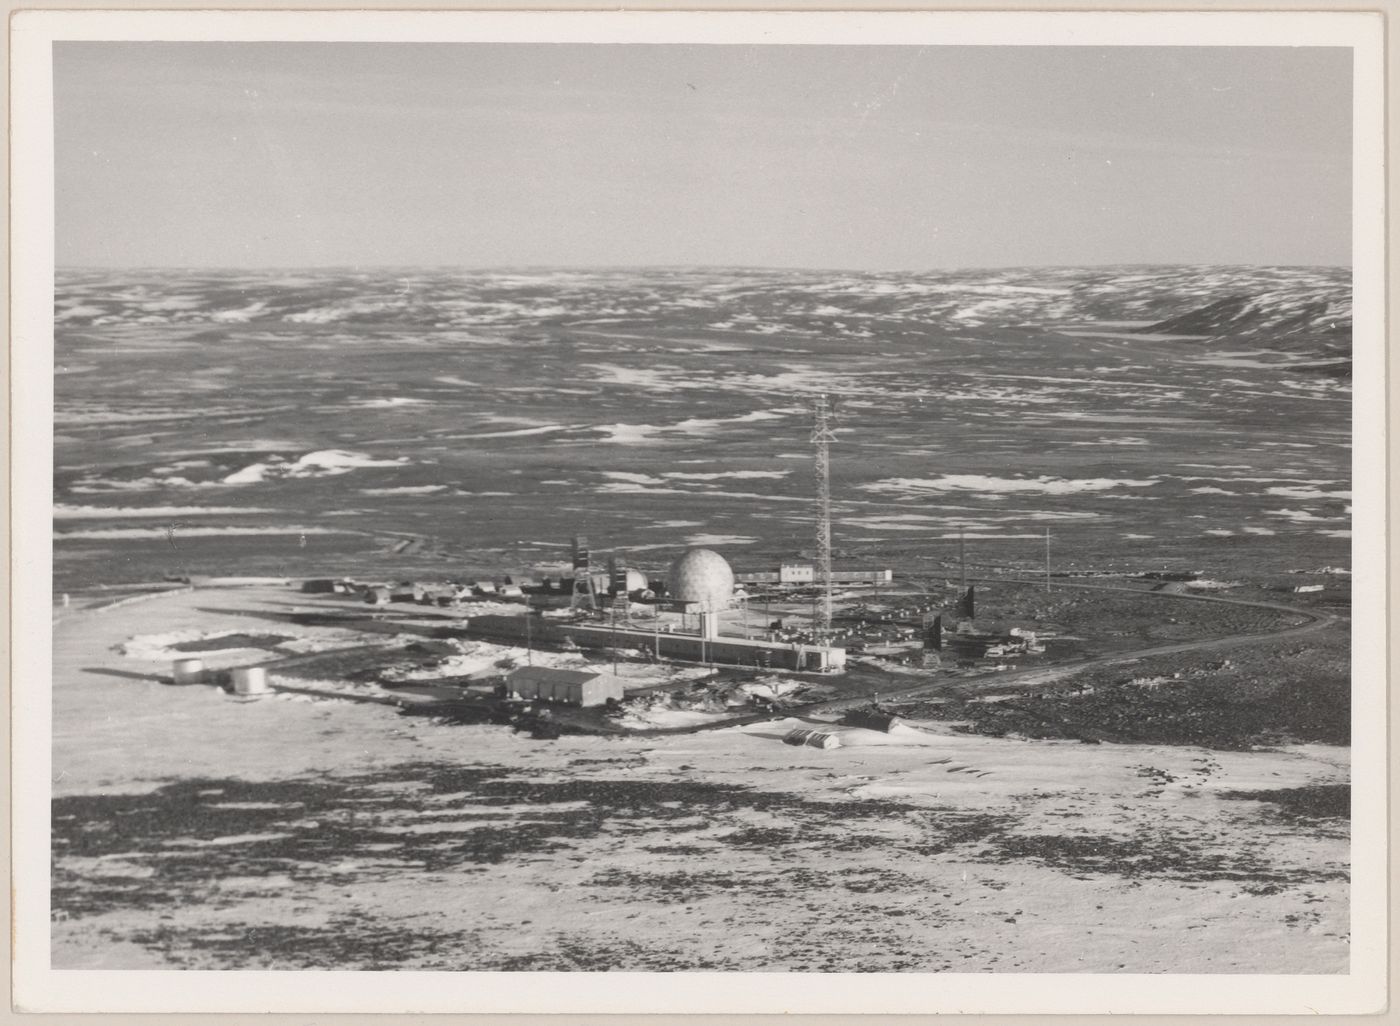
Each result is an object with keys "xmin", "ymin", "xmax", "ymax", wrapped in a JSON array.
[{"xmin": 52, "ymin": 586, "xmax": 1348, "ymax": 973}]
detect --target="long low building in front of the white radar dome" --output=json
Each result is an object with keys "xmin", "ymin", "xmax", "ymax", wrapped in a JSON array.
[{"xmin": 466, "ymin": 614, "xmax": 846, "ymax": 672}]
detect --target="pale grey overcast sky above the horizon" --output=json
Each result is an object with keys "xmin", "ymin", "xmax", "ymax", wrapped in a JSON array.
[{"xmin": 55, "ymin": 42, "xmax": 1351, "ymax": 269}]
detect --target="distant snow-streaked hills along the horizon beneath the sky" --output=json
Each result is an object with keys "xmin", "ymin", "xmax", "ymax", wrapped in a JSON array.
[{"xmin": 55, "ymin": 266, "xmax": 1351, "ymax": 356}]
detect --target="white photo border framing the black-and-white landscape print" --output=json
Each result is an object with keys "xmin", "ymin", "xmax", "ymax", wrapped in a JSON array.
[{"xmin": 10, "ymin": 10, "xmax": 1389, "ymax": 1015}]
